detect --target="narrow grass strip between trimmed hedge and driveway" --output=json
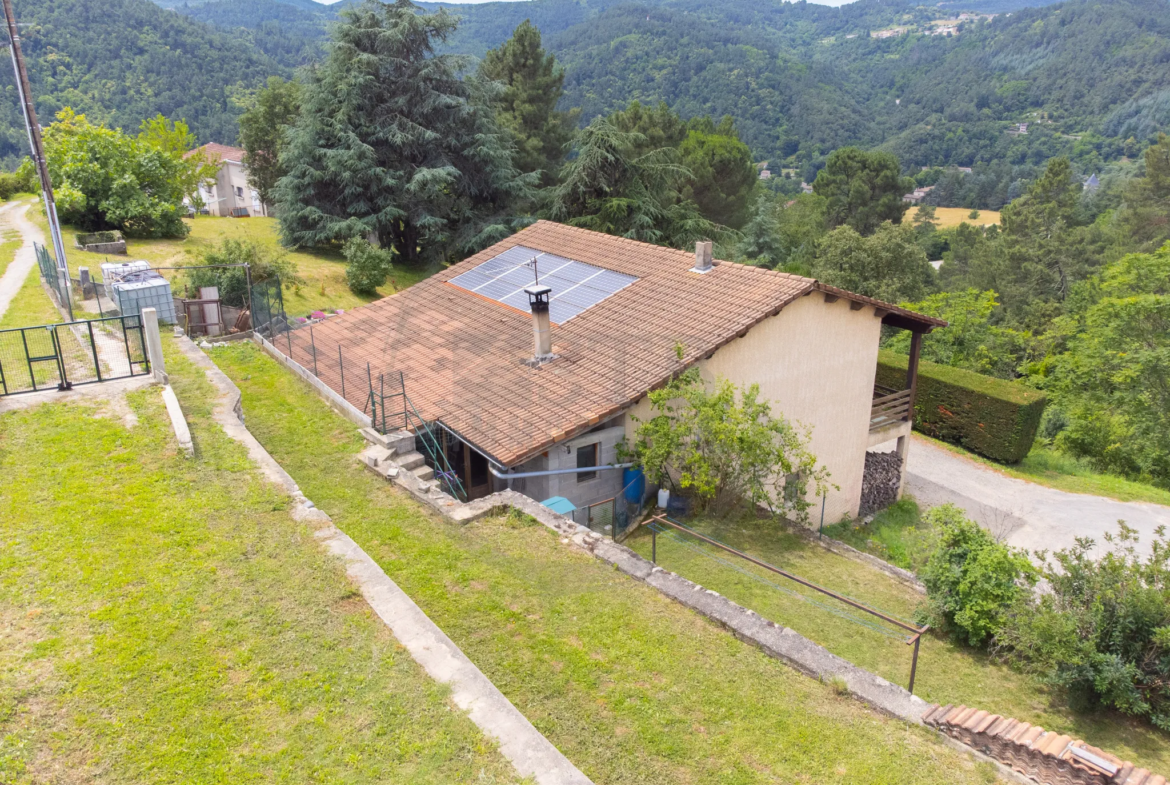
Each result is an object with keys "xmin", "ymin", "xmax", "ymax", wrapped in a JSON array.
[{"xmin": 914, "ymin": 433, "xmax": 1170, "ymax": 504}]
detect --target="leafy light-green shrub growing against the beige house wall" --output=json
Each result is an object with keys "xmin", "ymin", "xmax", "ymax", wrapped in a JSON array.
[{"xmin": 622, "ymin": 369, "xmax": 828, "ymax": 521}]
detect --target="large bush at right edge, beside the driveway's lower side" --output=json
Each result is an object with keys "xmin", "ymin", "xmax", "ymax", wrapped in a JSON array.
[{"xmin": 996, "ymin": 523, "xmax": 1170, "ymax": 730}]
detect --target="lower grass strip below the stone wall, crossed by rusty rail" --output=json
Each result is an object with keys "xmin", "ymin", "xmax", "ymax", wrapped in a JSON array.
[{"xmin": 641, "ymin": 510, "xmax": 1170, "ymax": 771}]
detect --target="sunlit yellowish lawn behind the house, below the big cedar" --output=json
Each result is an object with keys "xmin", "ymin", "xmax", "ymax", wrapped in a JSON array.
[{"xmin": 28, "ymin": 207, "xmax": 433, "ymax": 316}]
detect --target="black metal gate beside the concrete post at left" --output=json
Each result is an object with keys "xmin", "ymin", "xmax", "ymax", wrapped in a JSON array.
[{"xmin": 0, "ymin": 315, "xmax": 151, "ymax": 395}]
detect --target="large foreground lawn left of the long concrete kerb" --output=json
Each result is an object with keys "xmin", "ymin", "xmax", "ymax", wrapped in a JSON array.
[{"xmin": 0, "ymin": 342, "xmax": 516, "ymax": 785}]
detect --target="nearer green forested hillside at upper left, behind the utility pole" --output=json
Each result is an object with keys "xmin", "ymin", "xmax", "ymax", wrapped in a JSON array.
[{"xmin": 0, "ymin": 0, "xmax": 288, "ymax": 164}]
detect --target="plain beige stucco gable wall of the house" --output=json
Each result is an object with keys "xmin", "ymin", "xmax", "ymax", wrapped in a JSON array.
[{"xmin": 626, "ymin": 292, "xmax": 881, "ymax": 523}]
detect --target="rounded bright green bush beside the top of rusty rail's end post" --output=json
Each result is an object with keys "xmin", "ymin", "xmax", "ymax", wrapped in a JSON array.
[{"xmin": 918, "ymin": 504, "xmax": 1037, "ymax": 646}]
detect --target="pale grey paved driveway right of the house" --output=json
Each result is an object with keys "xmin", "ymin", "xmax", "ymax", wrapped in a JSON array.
[{"xmin": 906, "ymin": 436, "xmax": 1170, "ymax": 555}]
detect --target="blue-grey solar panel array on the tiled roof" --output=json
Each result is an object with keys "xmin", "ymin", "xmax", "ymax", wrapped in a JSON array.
[{"xmin": 450, "ymin": 246, "xmax": 638, "ymax": 324}]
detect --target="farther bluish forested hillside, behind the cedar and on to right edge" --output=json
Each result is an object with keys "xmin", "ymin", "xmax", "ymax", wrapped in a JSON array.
[{"xmin": 175, "ymin": 0, "xmax": 1170, "ymax": 168}]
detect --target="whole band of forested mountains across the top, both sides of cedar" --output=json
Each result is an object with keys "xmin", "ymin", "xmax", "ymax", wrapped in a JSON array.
[{"xmin": 0, "ymin": 0, "xmax": 1170, "ymax": 166}]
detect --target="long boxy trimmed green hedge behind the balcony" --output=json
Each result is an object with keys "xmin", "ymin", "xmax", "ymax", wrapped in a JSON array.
[{"xmin": 876, "ymin": 350, "xmax": 1048, "ymax": 463}]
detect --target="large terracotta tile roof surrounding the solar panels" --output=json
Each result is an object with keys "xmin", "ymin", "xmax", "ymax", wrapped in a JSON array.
[{"xmin": 304, "ymin": 221, "xmax": 941, "ymax": 467}]
